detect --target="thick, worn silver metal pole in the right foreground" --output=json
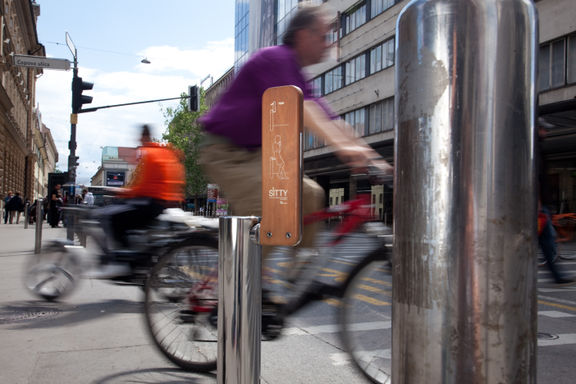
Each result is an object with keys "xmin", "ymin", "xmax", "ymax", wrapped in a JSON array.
[{"xmin": 392, "ymin": 0, "xmax": 537, "ymax": 384}]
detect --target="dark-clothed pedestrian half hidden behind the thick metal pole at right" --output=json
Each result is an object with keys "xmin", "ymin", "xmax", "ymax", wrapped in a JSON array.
[{"xmin": 537, "ymin": 118, "xmax": 576, "ymax": 285}]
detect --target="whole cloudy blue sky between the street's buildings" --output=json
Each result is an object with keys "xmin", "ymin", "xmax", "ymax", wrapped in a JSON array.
[{"xmin": 36, "ymin": 0, "xmax": 235, "ymax": 185}]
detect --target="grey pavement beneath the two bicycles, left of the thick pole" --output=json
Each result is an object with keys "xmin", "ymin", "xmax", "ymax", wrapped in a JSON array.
[{"xmin": 0, "ymin": 223, "xmax": 366, "ymax": 384}]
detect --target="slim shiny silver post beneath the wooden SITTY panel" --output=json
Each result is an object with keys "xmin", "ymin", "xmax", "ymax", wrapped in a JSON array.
[{"xmin": 217, "ymin": 216, "xmax": 262, "ymax": 384}]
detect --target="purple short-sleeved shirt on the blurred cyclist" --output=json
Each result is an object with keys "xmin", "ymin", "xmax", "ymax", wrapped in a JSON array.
[{"xmin": 200, "ymin": 45, "xmax": 335, "ymax": 149}]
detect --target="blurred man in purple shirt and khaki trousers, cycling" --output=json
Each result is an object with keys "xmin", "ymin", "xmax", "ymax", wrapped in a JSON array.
[{"xmin": 200, "ymin": 7, "xmax": 392, "ymax": 253}]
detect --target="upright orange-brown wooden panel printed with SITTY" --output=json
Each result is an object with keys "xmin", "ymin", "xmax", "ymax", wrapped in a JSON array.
[{"xmin": 260, "ymin": 86, "xmax": 303, "ymax": 246}]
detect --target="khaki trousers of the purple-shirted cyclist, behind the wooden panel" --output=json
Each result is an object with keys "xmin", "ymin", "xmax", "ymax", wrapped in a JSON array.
[{"xmin": 200, "ymin": 143, "xmax": 324, "ymax": 258}]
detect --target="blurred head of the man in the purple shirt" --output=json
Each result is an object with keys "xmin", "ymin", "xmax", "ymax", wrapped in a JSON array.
[{"xmin": 282, "ymin": 6, "xmax": 330, "ymax": 67}]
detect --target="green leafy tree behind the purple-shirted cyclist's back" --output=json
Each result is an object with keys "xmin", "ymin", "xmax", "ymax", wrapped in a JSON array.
[{"xmin": 162, "ymin": 90, "xmax": 207, "ymax": 210}]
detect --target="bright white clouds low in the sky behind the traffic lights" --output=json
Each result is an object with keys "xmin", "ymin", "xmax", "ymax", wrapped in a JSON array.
[{"xmin": 36, "ymin": 39, "xmax": 234, "ymax": 184}]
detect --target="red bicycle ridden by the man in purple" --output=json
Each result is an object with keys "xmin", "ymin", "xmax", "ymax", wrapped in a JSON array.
[{"xmin": 144, "ymin": 175, "xmax": 392, "ymax": 383}]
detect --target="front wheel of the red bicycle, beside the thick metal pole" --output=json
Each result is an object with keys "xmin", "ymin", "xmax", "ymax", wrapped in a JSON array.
[{"xmin": 339, "ymin": 249, "xmax": 392, "ymax": 383}]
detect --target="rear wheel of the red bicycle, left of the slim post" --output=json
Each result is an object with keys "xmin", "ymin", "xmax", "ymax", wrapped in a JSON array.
[{"xmin": 144, "ymin": 235, "xmax": 218, "ymax": 372}]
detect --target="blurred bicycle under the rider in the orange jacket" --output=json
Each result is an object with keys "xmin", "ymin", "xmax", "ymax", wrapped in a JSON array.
[{"xmin": 24, "ymin": 206, "xmax": 219, "ymax": 301}]
